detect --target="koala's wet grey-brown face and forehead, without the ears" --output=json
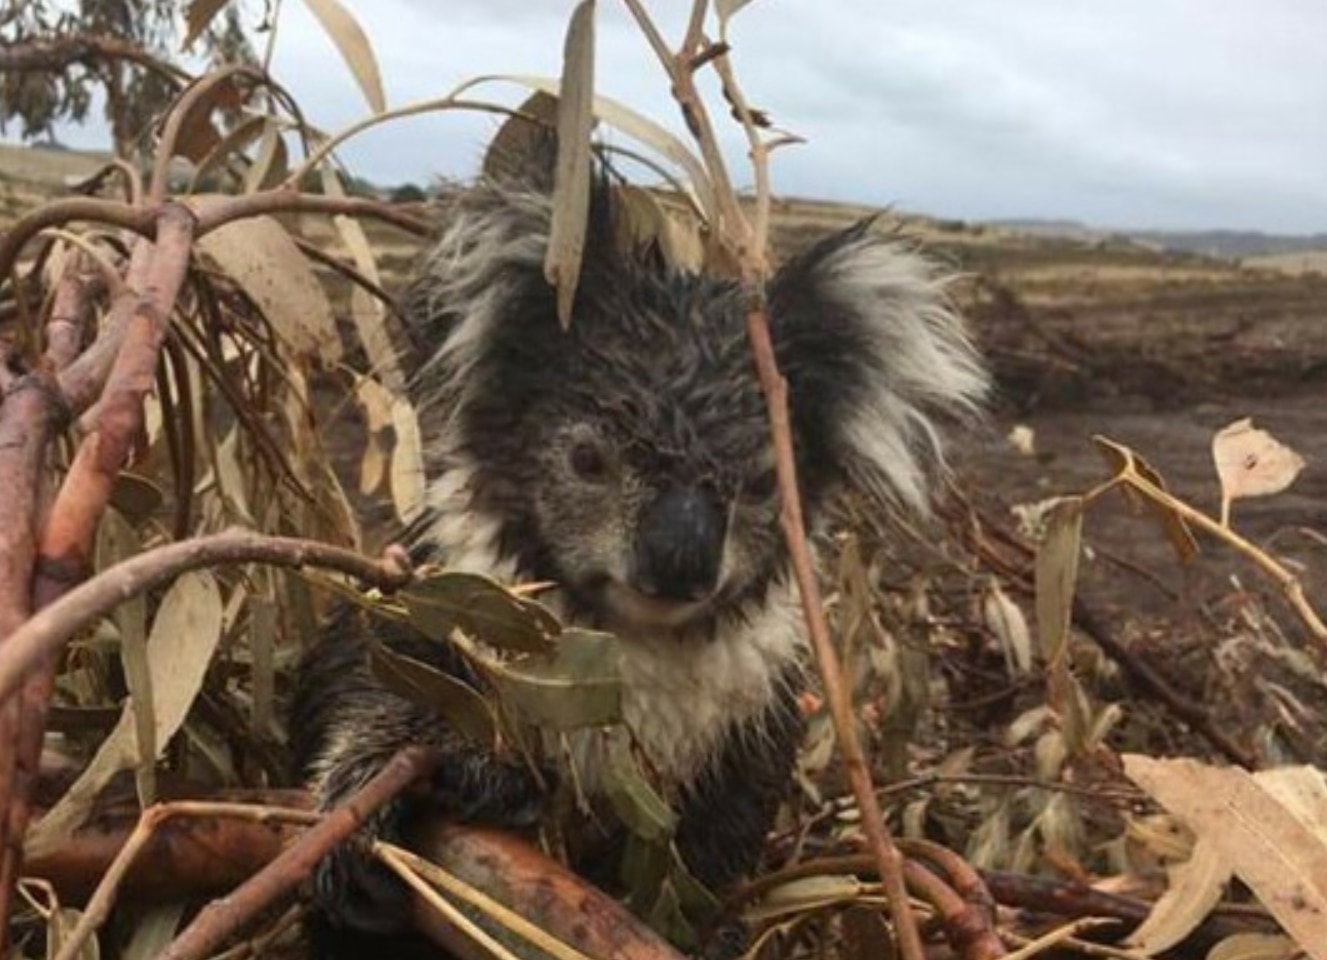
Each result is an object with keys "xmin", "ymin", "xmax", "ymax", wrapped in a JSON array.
[{"xmin": 503, "ymin": 266, "xmax": 783, "ymax": 633}]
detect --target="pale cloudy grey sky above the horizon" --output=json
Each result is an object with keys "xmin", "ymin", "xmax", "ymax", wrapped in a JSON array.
[{"xmin": 51, "ymin": 0, "xmax": 1327, "ymax": 234}]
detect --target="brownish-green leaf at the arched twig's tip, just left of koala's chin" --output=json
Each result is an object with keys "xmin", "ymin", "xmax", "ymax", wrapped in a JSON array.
[{"xmin": 398, "ymin": 571, "xmax": 561, "ymax": 653}]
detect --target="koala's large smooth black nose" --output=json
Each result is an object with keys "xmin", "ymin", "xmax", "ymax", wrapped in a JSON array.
[{"xmin": 634, "ymin": 487, "xmax": 727, "ymax": 600}]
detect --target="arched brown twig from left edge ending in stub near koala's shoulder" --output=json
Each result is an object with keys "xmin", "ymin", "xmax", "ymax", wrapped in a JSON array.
[{"xmin": 0, "ymin": 530, "xmax": 411, "ymax": 701}]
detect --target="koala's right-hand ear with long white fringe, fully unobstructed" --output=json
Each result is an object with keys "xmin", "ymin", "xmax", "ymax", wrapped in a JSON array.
[{"xmin": 770, "ymin": 220, "xmax": 990, "ymax": 513}]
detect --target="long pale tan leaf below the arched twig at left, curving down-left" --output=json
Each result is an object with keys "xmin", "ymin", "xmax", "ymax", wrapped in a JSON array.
[{"xmin": 24, "ymin": 571, "xmax": 223, "ymax": 855}]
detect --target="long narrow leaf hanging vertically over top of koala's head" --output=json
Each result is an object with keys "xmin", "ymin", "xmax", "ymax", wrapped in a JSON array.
[{"xmin": 544, "ymin": 0, "xmax": 594, "ymax": 327}]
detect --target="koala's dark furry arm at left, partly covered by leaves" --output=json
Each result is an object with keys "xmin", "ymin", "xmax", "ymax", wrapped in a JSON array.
[{"xmin": 289, "ymin": 609, "xmax": 543, "ymax": 932}]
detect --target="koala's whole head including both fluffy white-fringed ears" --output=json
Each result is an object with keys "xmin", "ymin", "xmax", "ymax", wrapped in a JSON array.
[{"xmin": 409, "ymin": 176, "xmax": 986, "ymax": 632}]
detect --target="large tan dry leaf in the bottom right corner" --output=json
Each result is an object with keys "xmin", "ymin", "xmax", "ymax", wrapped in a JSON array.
[{"xmin": 1124, "ymin": 754, "xmax": 1327, "ymax": 960}]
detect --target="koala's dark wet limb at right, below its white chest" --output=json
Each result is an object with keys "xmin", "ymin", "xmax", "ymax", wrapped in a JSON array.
[{"xmin": 677, "ymin": 684, "xmax": 804, "ymax": 892}]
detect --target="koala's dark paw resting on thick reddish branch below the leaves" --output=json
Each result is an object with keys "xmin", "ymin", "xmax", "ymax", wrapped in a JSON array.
[{"xmin": 429, "ymin": 752, "xmax": 553, "ymax": 830}]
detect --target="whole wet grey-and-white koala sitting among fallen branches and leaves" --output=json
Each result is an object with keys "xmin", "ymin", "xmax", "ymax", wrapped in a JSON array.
[{"xmin": 292, "ymin": 154, "xmax": 987, "ymax": 950}]
